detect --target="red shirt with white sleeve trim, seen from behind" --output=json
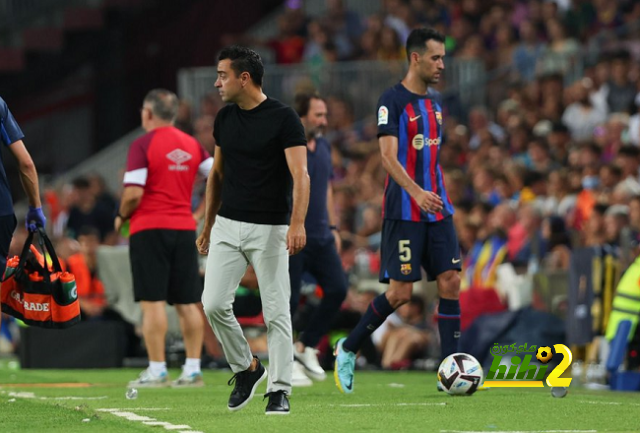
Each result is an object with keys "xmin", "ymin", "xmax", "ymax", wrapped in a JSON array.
[{"xmin": 124, "ymin": 126, "xmax": 213, "ymax": 234}]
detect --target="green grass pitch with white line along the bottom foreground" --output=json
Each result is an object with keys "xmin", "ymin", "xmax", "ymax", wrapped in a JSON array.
[{"xmin": 0, "ymin": 366, "xmax": 640, "ymax": 433}]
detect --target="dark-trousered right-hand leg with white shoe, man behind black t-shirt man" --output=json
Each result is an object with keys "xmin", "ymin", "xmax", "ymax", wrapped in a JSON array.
[{"xmin": 294, "ymin": 239, "xmax": 347, "ymax": 380}]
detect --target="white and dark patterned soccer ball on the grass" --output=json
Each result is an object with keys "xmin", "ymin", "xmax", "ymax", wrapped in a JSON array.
[{"xmin": 438, "ymin": 353, "xmax": 482, "ymax": 395}]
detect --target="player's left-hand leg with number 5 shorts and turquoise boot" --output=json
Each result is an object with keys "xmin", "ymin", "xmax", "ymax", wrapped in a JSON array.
[{"xmin": 334, "ymin": 220, "xmax": 426, "ymax": 393}]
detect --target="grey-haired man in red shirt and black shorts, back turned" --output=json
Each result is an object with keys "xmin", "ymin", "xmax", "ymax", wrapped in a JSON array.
[{"xmin": 115, "ymin": 89, "xmax": 213, "ymax": 387}]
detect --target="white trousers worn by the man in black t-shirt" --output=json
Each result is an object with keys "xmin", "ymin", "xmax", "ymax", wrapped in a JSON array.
[{"xmin": 202, "ymin": 216, "xmax": 293, "ymax": 394}]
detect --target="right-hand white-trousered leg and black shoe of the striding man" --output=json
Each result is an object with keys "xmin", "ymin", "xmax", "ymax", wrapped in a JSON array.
[{"xmin": 242, "ymin": 224, "xmax": 293, "ymax": 414}]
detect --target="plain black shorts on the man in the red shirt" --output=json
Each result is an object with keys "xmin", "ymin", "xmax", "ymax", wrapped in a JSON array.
[{"xmin": 129, "ymin": 229, "xmax": 203, "ymax": 304}]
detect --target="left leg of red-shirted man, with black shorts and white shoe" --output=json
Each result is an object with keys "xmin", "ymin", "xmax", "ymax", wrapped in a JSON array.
[{"xmin": 129, "ymin": 230, "xmax": 170, "ymax": 387}]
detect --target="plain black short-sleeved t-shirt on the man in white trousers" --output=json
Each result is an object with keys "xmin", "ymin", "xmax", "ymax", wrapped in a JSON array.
[{"xmin": 213, "ymin": 98, "xmax": 307, "ymax": 225}]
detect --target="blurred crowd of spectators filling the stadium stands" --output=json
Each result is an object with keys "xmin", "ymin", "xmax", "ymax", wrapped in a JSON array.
[{"xmin": 3, "ymin": 0, "xmax": 640, "ymax": 368}]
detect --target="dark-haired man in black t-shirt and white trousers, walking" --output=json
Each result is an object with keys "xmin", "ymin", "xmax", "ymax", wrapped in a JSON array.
[{"xmin": 196, "ymin": 46, "xmax": 309, "ymax": 415}]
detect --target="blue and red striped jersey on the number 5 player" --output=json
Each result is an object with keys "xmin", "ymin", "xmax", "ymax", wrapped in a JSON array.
[{"xmin": 378, "ymin": 83, "xmax": 454, "ymax": 222}]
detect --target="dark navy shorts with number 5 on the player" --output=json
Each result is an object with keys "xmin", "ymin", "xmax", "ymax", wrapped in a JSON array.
[{"xmin": 380, "ymin": 216, "xmax": 462, "ymax": 284}]
